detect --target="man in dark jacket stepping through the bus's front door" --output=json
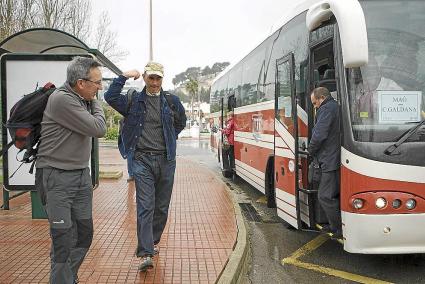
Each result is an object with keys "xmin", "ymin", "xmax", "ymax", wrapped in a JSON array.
[{"xmin": 308, "ymin": 87, "xmax": 342, "ymax": 238}]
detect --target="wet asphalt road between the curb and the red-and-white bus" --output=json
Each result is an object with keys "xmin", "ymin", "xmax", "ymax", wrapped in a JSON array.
[{"xmin": 177, "ymin": 139, "xmax": 425, "ymax": 283}]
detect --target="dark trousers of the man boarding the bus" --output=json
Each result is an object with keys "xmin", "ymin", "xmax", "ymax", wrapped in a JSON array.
[{"xmin": 318, "ymin": 169, "xmax": 342, "ymax": 232}]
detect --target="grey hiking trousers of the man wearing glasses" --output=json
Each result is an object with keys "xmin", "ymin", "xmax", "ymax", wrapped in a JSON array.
[{"xmin": 36, "ymin": 168, "xmax": 93, "ymax": 284}]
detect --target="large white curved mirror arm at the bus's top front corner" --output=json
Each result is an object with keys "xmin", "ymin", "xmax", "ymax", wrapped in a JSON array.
[{"xmin": 306, "ymin": 0, "xmax": 369, "ymax": 68}]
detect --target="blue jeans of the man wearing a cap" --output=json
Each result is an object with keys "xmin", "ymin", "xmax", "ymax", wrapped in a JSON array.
[{"xmin": 133, "ymin": 152, "xmax": 176, "ymax": 257}]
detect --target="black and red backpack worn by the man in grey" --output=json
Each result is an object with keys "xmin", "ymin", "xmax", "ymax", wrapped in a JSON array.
[{"xmin": 1, "ymin": 82, "xmax": 56, "ymax": 177}]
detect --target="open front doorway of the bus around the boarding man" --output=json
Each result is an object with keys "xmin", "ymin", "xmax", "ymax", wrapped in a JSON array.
[{"xmin": 300, "ymin": 24, "xmax": 338, "ymax": 229}]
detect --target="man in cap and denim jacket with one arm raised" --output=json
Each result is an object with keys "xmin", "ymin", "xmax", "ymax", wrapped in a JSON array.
[{"xmin": 105, "ymin": 62, "xmax": 186, "ymax": 271}]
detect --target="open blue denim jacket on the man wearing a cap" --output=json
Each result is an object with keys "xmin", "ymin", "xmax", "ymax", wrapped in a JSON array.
[{"xmin": 105, "ymin": 75, "xmax": 186, "ymax": 161}]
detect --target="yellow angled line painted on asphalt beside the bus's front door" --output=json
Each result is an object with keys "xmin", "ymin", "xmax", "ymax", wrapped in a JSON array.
[{"xmin": 281, "ymin": 235, "xmax": 391, "ymax": 284}]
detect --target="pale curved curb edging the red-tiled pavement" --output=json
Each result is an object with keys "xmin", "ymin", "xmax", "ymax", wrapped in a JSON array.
[{"xmin": 215, "ymin": 179, "xmax": 251, "ymax": 284}]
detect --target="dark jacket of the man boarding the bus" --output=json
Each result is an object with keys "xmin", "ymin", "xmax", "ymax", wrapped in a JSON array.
[{"xmin": 308, "ymin": 97, "xmax": 341, "ymax": 172}]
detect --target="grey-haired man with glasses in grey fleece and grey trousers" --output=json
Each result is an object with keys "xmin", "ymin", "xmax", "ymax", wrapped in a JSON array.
[{"xmin": 36, "ymin": 57, "xmax": 106, "ymax": 284}]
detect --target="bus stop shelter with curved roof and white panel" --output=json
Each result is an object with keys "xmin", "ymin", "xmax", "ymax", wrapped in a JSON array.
[{"xmin": 0, "ymin": 28, "xmax": 121, "ymax": 218}]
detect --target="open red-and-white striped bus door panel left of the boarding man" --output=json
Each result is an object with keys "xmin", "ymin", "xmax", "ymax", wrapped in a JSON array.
[{"xmin": 274, "ymin": 53, "xmax": 300, "ymax": 228}]
